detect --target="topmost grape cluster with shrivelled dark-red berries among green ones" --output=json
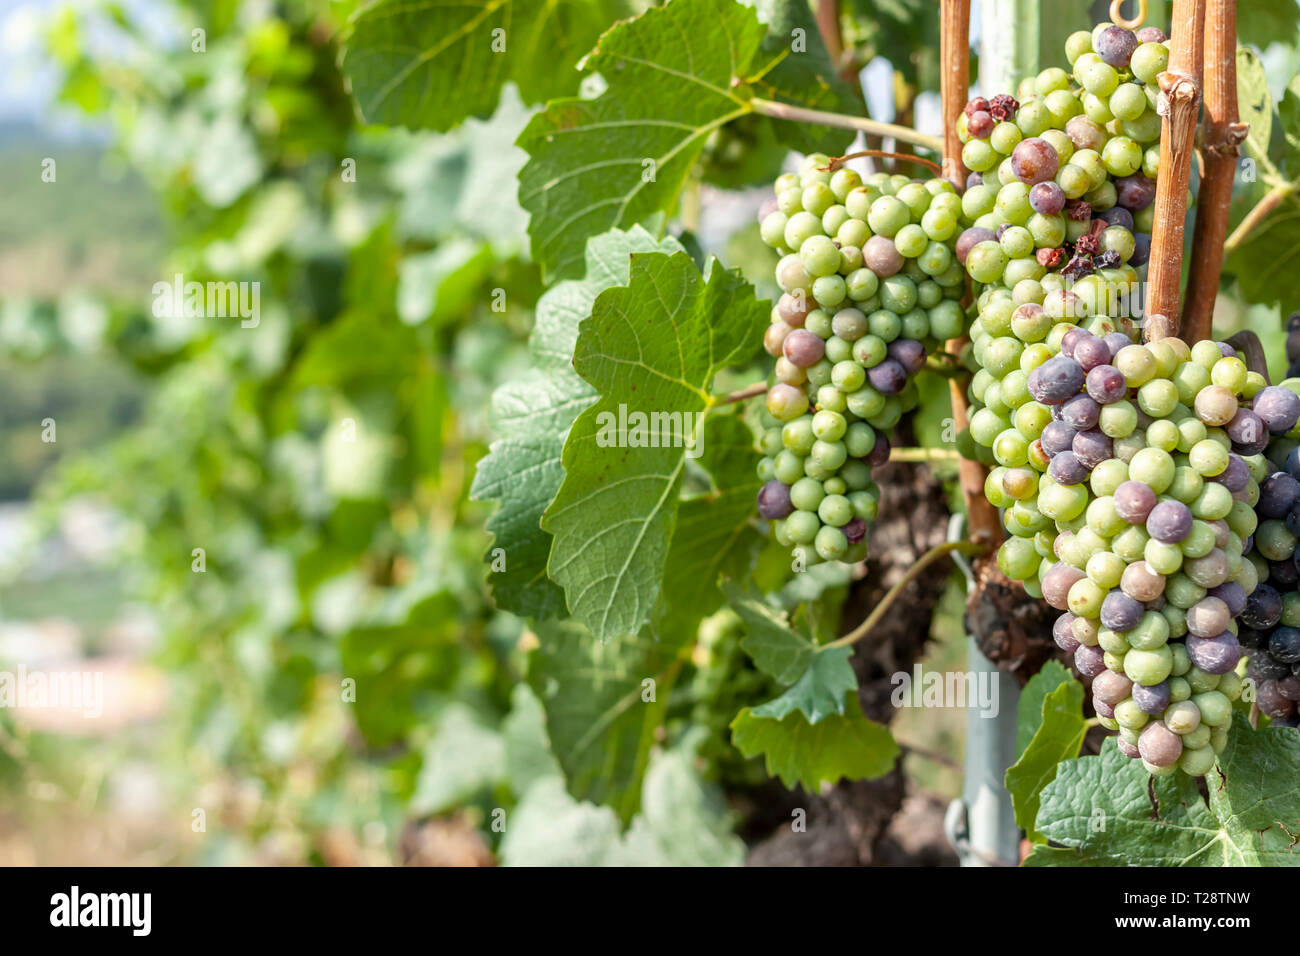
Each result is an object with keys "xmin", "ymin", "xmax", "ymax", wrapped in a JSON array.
[{"xmin": 957, "ymin": 23, "xmax": 1169, "ymax": 298}]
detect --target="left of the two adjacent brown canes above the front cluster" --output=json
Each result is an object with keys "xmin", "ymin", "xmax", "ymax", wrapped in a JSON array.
[{"xmin": 1143, "ymin": 0, "xmax": 1205, "ymax": 342}]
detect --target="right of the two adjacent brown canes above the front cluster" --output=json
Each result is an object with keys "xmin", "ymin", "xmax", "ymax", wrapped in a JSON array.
[{"xmin": 1183, "ymin": 0, "xmax": 1242, "ymax": 342}]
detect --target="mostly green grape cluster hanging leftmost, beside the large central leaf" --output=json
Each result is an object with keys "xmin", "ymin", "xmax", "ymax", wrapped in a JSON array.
[{"xmin": 758, "ymin": 155, "xmax": 965, "ymax": 563}]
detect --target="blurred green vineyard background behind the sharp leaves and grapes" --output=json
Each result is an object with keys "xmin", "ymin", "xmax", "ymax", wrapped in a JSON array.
[{"xmin": 0, "ymin": 0, "xmax": 1292, "ymax": 864}]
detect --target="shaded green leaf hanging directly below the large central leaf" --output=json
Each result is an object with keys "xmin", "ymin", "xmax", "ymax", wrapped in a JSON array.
[{"xmin": 528, "ymin": 620, "xmax": 689, "ymax": 821}]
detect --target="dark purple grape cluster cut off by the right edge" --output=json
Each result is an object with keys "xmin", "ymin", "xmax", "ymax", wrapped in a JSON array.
[{"xmin": 1238, "ymin": 395, "xmax": 1300, "ymax": 727}]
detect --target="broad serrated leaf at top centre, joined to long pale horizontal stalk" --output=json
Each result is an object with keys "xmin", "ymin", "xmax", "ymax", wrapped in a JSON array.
[{"xmin": 519, "ymin": 0, "xmax": 849, "ymax": 276}]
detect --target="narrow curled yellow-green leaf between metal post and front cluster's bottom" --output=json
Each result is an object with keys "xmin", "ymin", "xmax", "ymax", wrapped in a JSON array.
[{"xmin": 1006, "ymin": 665, "xmax": 1088, "ymax": 843}]
